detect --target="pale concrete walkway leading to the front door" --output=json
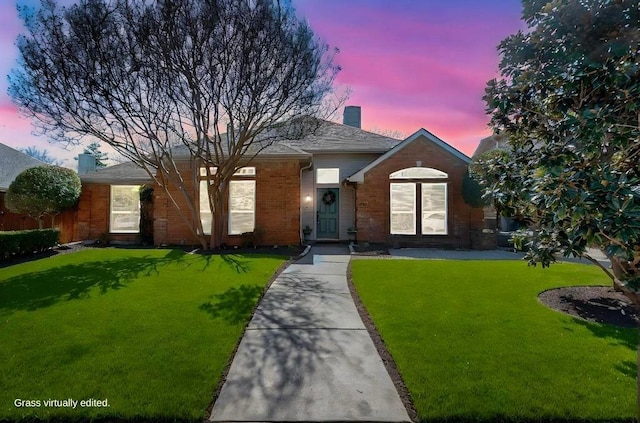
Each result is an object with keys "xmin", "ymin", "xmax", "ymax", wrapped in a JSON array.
[{"xmin": 210, "ymin": 245, "xmax": 410, "ymax": 422}]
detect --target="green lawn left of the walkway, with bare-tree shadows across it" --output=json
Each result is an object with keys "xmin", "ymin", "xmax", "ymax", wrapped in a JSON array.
[{"xmin": 0, "ymin": 249, "xmax": 284, "ymax": 421}]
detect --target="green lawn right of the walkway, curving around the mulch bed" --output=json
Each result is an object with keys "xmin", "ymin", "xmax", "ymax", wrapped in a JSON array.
[{"xmin": 352, "ymin": 260, "xmax": 638, "ymax": 421}]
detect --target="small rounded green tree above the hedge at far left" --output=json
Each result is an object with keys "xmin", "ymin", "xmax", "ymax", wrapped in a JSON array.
[{"xmin": 5, "ymin": 165, "xmax": 82, "ymax": 229}]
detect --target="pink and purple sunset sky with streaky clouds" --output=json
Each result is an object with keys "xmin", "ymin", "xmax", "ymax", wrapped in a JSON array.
[{"xmin": 0, "ymin": 0, "xmax": 523, "ymax": 167}]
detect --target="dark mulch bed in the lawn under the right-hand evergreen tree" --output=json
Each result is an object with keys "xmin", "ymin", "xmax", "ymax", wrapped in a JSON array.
[{"xmin": 538, "ymin": 286, "xmax": 639, "ymax": 328}]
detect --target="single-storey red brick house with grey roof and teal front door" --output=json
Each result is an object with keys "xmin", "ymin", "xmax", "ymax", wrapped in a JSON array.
[{"xmin": 77, "ymin": 106, "xmax": 484, "ymax": 248}]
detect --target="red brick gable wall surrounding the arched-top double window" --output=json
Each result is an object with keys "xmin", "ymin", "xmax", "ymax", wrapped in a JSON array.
[{"xmin": 356, "ymin": 137, "xmax": 483, "ymax": 248}]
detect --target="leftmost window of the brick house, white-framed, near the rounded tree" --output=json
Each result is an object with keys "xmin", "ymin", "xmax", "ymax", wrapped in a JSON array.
[{"xmin": 109, "ymin": 185, "xmax": 140, "ymax": 234}]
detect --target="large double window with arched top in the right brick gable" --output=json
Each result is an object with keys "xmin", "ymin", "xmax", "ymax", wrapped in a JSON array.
[{"xmin": 389, "ymin": 167, "xmax": 448, "ymax": 235}]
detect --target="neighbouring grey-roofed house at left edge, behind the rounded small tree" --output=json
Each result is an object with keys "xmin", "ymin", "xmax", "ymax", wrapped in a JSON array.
[{"xmin": 0, "ymin": 144, "xmax": 45, "ymax": 231}]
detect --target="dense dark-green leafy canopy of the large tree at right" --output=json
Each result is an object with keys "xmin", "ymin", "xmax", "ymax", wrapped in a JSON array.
[{"xmin": 483, "ymin": 0, "xmax": 640, "ymax": 298}]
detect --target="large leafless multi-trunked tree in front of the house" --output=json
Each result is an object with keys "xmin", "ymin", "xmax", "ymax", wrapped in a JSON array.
[{"xmin": 10, "ymin": 0, "xmax": 339, "ymax": 248}]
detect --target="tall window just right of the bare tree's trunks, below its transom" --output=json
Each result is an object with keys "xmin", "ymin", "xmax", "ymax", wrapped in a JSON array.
[{"xmin": 229, "ymin": 181, "xmax": 256, "ymax": 235}]
